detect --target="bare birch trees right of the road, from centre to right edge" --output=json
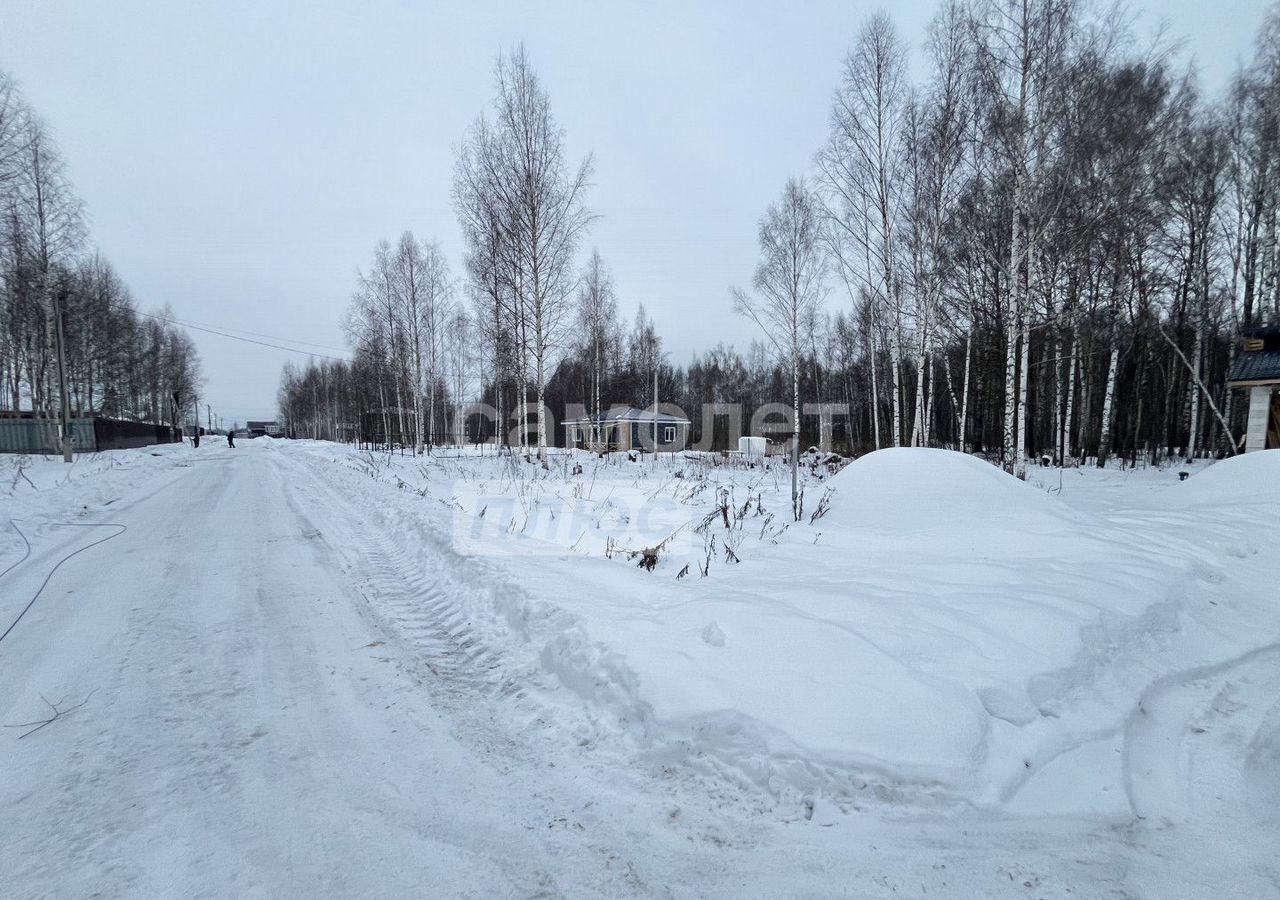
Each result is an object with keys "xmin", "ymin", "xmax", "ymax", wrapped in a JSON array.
[{"xmin": 282, "ymin": 0, "xmax": 1280, "ymax": 472}]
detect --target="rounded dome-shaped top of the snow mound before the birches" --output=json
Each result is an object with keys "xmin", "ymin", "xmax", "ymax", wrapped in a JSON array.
[{"xmin": 824, "ymin": 447, "xmax": 1078, "ymax": 533}]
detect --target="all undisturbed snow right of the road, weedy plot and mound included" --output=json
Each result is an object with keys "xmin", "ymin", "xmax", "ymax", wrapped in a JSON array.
[{"xmin": 280, "ymin": 447, "xmax": 1280, "ymax": 812}]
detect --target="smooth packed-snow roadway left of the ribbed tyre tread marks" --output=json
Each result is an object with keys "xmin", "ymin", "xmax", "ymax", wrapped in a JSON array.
[{"xmin": 0, "ymin": 452, "xmax": 701, "ymax": 897}]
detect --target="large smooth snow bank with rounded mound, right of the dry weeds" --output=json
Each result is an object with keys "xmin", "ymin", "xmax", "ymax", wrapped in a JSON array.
[{"xmin": 540, "ymin": 449, "xmax": 1280, "ymax": 803}]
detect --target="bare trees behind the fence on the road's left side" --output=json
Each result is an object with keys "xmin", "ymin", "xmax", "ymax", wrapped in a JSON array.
[{"xmin": 0, "ymin": 70, "xmax": 201, "ymax": 425}]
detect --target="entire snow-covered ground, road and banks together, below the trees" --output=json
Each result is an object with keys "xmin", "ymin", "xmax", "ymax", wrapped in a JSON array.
[{"xmin": 0, "ymin": 439, "xmax": 1280, "ymax": 899}]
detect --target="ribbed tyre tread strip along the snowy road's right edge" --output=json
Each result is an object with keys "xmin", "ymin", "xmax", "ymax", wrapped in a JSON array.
[{"xmin": 273, "ymin": 442, "xmax": 670, "ymax": 773}]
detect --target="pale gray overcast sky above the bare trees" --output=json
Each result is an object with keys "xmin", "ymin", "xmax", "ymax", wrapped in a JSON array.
[{"xmin": 0, "ymin": 0, "xmax": 1266, "ymax": 420}]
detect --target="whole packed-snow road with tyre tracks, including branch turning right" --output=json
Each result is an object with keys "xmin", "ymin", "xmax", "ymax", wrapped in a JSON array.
[{"xmin": 0, "ymin": 442, "xmax": 1280, "ymax": 900}]
